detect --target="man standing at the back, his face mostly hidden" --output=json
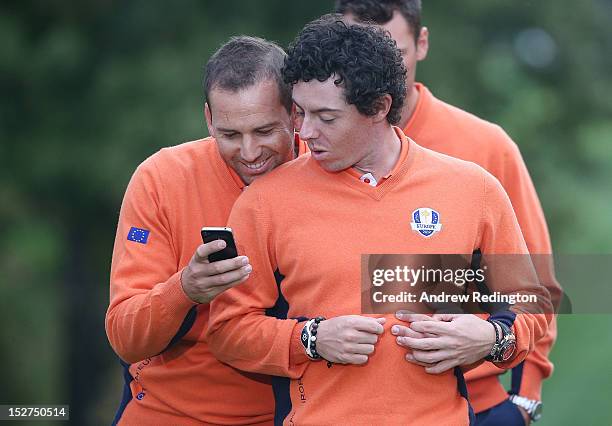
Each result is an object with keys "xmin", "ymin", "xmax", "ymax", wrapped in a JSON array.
[{"xmin": 335, "ymin": 0, "xmax": 560, "ymax": 424}]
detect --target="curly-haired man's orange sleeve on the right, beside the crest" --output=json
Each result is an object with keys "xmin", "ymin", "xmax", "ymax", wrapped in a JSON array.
[{"xmin": 480, "ymin": 174, "xmax": 552, "ymax": 368}]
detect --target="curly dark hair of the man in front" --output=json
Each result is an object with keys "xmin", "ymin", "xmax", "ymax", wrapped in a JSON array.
[{"xmin": 283, "ymin": 15, "xmax": 406, "ymax": 124}]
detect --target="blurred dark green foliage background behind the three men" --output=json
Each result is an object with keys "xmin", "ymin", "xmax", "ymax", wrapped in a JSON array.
[{"xmin": 0, "ymin": 0, "xmax": 612, "ymax": 425}]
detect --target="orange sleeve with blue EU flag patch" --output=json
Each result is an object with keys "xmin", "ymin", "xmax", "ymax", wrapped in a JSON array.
[{"xmin": 106, "ymin": 156, "xmax": 196, "ymax": 363}]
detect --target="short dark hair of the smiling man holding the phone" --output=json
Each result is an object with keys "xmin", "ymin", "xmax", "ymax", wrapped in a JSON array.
[{"xmin": 204, "ymin": 36, "xmax": 292, "ymax": 112}]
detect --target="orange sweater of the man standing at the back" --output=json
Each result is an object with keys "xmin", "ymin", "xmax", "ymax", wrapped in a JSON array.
[{"xmin": 404, "ymin": 83, "xmax": 561, "ymax": 412}]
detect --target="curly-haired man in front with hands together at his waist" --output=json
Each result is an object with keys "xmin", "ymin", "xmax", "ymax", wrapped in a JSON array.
[{"xmin": 207, "ymin": 16, "xmax": 546, "ymax": 425}]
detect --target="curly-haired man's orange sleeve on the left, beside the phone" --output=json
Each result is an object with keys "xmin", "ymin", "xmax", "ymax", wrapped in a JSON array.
[{"xmin": 207, "ymin": 185, "xmax": 308, "ymax": 378}]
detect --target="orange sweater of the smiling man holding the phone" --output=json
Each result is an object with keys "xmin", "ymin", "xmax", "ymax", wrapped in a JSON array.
[{"xmin": 106, "ymin": 138, "xmax": 305, "ymax": 425}]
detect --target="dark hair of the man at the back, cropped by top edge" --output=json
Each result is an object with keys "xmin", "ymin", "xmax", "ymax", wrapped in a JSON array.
[{"xmin": 336, "ymin": 0, "xmax": 421, "ymax": 42}]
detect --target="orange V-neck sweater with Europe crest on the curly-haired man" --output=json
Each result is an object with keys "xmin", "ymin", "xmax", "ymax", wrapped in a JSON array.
[{"xmin": 209, "ymin": 129, "xmax": 547, "ymax": 425}]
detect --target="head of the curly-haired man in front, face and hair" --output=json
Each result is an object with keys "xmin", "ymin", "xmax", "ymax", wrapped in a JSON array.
[{"xmin": 283, "ymin": 16, "xmax": 406, "ymax": 176}]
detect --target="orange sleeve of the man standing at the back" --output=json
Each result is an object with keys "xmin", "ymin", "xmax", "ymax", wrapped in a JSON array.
[{"xmin": 498, "ymin": 129, "xmax": 562, "ymax": 400}]
